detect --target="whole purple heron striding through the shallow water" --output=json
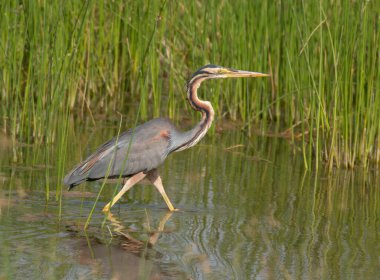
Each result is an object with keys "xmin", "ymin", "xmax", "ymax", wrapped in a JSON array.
[{"xmin": 64, "ymin": 65, "xmax": 269, "ymax": 211}]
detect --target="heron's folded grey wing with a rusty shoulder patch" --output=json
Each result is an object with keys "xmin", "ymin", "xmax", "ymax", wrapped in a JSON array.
[{"xmin": 64, "ymin": 119, "xmax": 171, "ymax": 185}]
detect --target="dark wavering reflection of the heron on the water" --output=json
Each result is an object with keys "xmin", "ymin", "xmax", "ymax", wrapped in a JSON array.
[{"xmin": 66, "ymin": 212, "xmax": 175, "ymax": 279}]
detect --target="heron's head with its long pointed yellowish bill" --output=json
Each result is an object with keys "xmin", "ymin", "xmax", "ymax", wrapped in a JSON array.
[{"xmin": 190, "ymin": 64, "xmax": 270, "ymax": 81}]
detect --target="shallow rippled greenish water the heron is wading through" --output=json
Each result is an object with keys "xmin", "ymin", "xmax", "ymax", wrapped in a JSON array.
[{"xmin": 0, "ymin": 128, "xmax": 380, "ymax": 279}]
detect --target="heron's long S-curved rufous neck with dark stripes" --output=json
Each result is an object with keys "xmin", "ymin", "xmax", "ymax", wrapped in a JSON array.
[{"xmin": 171, "ymin": 76, "xmax": 214, "ymax": 152}]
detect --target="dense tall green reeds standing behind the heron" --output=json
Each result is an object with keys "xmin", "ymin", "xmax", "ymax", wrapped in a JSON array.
[{"xmin": 0, "ymin": 0, "xmax": 380, "ymax": 168}]
